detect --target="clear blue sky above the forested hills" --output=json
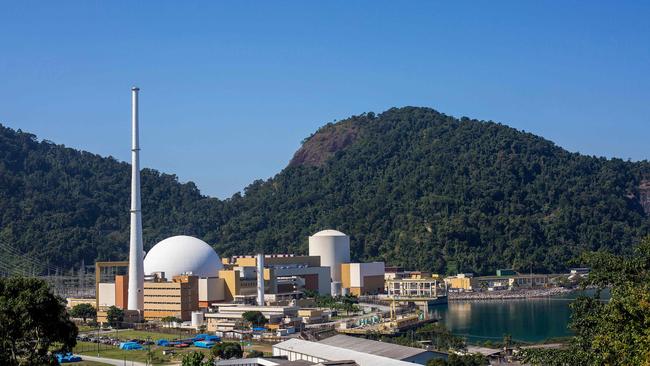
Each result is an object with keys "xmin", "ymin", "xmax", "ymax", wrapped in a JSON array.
[{"xmin": 0, "ymin": 1, "xmax": 650, "ymax": 198}]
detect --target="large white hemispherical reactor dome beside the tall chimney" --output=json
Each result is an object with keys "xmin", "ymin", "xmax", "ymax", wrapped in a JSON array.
[{"xmin": 144, "ymin": 235, "xmax": 223, "ymax": 280}]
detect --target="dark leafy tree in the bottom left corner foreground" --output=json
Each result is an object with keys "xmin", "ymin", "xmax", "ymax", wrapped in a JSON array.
[{"xmin": 0, "ymin": 277, "xmax": 78, "ymax": 366}]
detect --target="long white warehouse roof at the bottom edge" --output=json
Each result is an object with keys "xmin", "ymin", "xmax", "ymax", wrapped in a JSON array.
[{"xmin": 273, "ymin": 338, "xmax": 413, "ymax": 366}]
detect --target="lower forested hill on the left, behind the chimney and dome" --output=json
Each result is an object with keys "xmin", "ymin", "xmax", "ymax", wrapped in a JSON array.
[{"xmin": 0, "ymin": 125, "xmax": 225, "ymax": 268}]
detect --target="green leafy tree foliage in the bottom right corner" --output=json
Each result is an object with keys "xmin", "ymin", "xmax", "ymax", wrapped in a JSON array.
[{"xmin": 521, "ymin": 237, "xmax": 650, "ymax": 366}]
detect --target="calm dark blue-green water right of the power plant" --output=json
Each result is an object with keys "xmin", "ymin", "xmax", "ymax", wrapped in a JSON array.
[{"xmin": 429, "ymin": 294, "xmax": 604, "ymax": 342}]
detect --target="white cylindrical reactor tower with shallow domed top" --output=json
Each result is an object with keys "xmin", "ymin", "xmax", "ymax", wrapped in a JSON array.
[{"xmin": 309, "ymin": 230, "xmax": 350, "ymax": 282}]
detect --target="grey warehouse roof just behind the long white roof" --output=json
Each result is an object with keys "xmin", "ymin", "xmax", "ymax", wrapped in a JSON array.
[{"xmin": 318, "ymin": 334, "xmax": 427, "ymax": 360}]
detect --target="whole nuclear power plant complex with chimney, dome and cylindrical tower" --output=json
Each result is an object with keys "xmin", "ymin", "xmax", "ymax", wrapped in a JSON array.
[{"xmin": 85, "ymin": 87, "xmax": 446, "ymax": 344}]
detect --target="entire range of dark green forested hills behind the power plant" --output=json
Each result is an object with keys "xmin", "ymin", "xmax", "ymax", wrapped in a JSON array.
[{"xmin": 0, "ymin": 107, "xmax": 650, "ymax": 273}]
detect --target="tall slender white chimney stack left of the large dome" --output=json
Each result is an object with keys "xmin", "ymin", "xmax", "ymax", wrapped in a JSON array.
[{"xmin": 127, "ymin": 87, "xmax": 144, "ymax": 311}]
